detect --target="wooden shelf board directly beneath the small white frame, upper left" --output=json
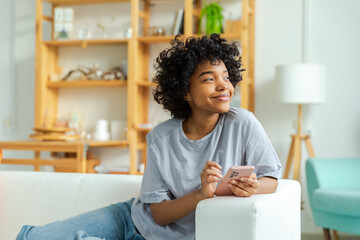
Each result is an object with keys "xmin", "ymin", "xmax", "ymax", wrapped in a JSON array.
[{"xmin": 44, "ymin": 38, "xmax": 129, "ymax": 48}]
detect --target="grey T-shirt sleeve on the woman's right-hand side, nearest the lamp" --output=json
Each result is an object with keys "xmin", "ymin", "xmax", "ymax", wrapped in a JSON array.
[{"xmin": 244, "ymin": 113, "xmax": 281, "ymax": 178}]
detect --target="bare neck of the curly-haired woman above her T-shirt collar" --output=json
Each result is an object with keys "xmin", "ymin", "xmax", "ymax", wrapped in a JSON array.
[{"xmin": 182, "ymin": 113, "xmax": 220, "ymax": 140}]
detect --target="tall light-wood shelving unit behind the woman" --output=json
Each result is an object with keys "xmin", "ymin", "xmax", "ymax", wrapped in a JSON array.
[{"xmin": 31, "ymin": 0, "xmax": 254, "ymax": 174}]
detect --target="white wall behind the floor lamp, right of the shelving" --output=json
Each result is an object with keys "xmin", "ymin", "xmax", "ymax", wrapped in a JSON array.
[{"xmin": 255, "ymin": 0, "xmax": 360, "ymax": 233}]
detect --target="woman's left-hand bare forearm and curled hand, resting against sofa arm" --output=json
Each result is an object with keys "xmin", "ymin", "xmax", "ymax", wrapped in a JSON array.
[{"xmin": 150, "ymin": 161, "xmax": 223, "ymax": 225}]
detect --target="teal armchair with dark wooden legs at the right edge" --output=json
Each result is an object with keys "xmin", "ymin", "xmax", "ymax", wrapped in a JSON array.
[{"xmin": 306, "ymin": 158, "xmax": 360, "ymax": 239}]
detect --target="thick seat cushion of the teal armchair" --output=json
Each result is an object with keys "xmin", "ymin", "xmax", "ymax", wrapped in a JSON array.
[{"xmin": 312, "ymin": 188, "xmax": 360, "ymax": 216}]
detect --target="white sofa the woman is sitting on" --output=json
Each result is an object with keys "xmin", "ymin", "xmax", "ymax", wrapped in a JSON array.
[{"xmin": 0, "ymin": 171, "xmax": 300, "ymax": 240}]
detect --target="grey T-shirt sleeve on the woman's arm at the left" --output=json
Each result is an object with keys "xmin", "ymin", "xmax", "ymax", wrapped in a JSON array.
[{"xmin": 140, "ymin": 144, "xmax": 173, "ymax": 203}]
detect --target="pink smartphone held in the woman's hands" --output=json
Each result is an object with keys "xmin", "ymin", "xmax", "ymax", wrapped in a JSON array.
[{"xmin": 215, "ymin": 166, "xmax": 254, "ymax": 196}]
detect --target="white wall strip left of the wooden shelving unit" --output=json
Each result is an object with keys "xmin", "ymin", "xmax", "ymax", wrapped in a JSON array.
[{"xmin": 0, "ymin": 0, "xmax": 35, "ymax": 170}]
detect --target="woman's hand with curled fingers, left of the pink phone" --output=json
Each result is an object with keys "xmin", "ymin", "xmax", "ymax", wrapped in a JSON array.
[{"xmin": 200, "ymin": 161, "xmax": 223, "ymax": 198}]
